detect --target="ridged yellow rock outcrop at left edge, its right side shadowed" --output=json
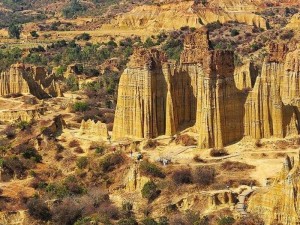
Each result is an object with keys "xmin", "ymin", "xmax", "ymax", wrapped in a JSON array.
[{"xmin": 0, "ymin": 64, "xmax": 62, "ymax": 99}]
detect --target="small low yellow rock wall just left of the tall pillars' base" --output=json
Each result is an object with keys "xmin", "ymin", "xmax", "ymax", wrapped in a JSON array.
[{"xmin": 80, "ymin": 120, "xmax": 108, "ymax": 139}]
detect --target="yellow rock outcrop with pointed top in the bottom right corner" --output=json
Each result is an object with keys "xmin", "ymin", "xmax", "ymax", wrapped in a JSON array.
[{"xmin": 248, "ymin": 156, "xmax": 300, "ymax": 225}]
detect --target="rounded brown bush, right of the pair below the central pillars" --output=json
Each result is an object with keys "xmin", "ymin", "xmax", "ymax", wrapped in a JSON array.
[{"xmin": 193, "ymin": 166, "xmax": 216, "ymax": 186}]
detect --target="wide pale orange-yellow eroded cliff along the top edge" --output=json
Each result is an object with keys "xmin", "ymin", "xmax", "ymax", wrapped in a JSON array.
[{"xmin": 105, "ymin": 0, "xmax": 267, "ymax": 33}]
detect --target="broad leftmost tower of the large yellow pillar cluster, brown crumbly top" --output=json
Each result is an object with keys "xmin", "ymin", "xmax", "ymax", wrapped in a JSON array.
[{"xmin": 113, "ymin": 49, "xmax": 173, "ymax": 138}]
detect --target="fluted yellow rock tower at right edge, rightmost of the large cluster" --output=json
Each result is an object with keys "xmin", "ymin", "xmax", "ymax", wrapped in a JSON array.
[{"xmin": 244, "ymin": 43, "xmax": 299, "ymax": 139}]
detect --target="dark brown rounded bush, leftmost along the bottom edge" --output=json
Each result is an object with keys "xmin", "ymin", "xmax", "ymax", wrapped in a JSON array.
[{"xmin": 26, "ymin": 198, "xmax": 52, "ymax": 221}]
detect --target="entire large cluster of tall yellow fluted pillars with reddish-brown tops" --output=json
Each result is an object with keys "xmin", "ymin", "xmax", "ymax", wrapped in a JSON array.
[{"xmin": 113, "ymin": 29, "xmax": 300, "ymax": 148}]
